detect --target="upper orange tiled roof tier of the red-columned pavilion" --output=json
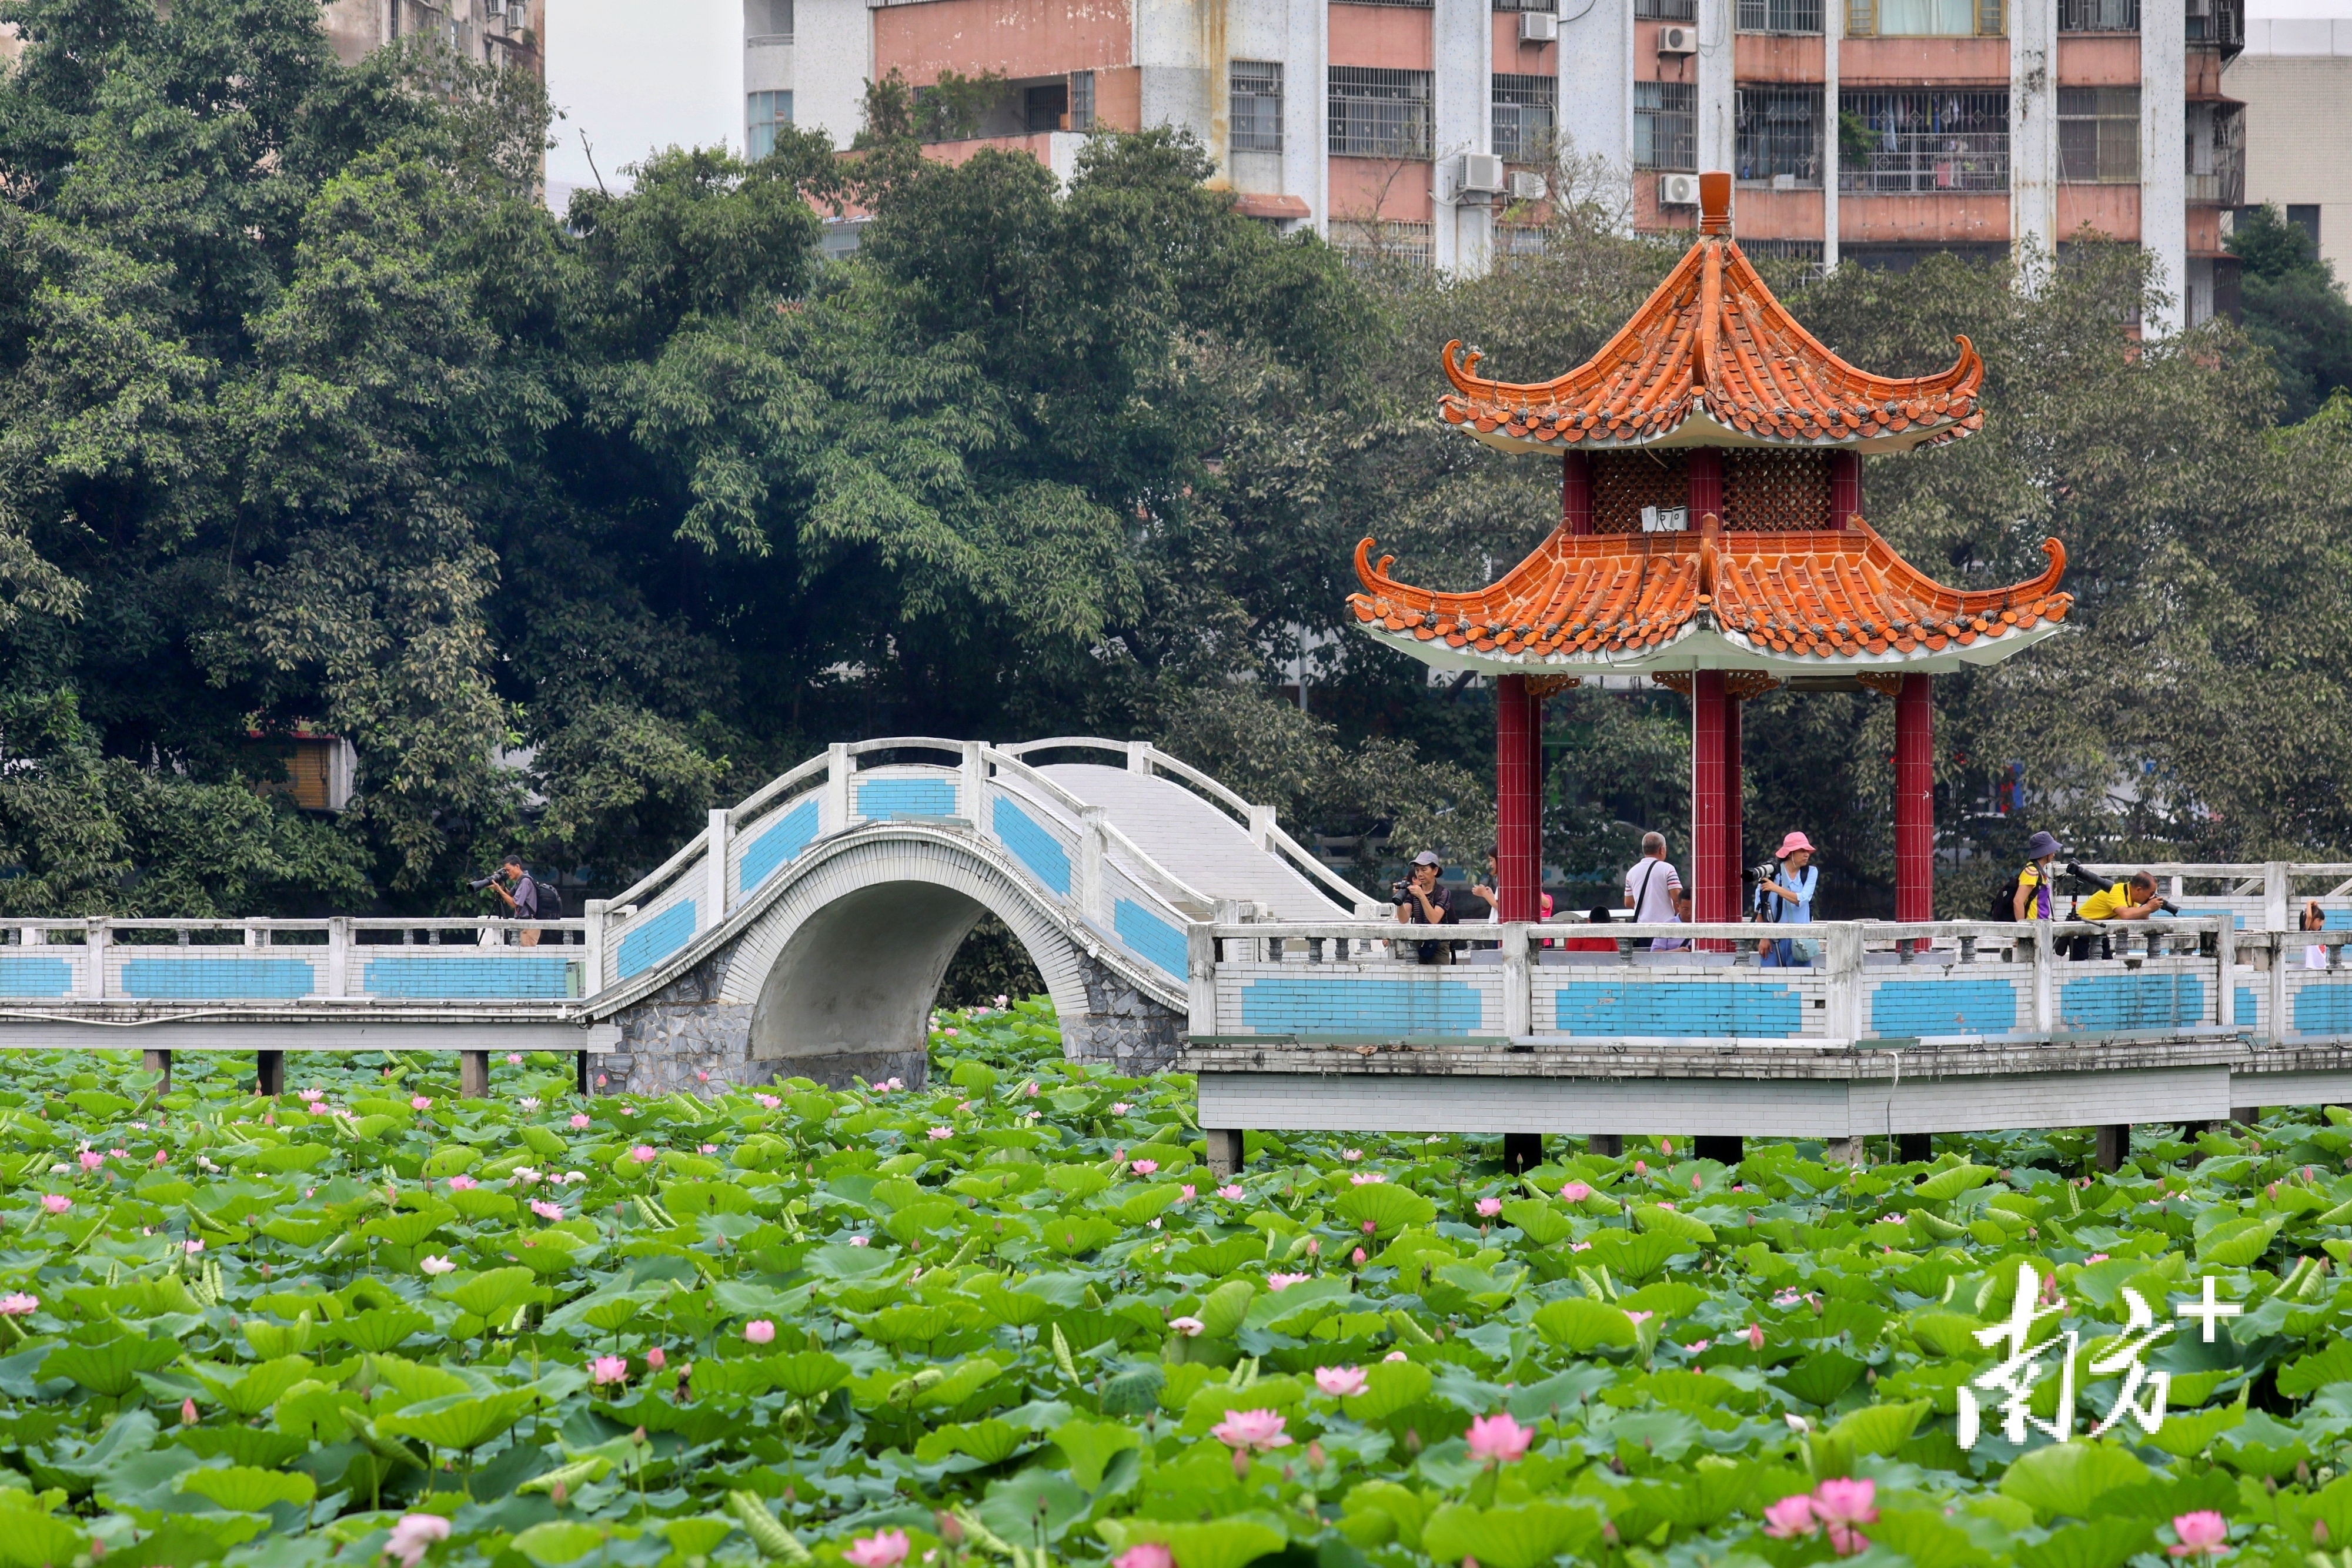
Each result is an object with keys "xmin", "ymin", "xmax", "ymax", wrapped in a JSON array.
[{"xmin": 1437, "ymin": 233, "xmax": 1985, "ymax": 452}]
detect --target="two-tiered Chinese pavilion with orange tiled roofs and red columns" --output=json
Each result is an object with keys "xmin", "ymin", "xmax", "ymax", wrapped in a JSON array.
[{"xmin": 1348, "ymin": 174, "xmax": 2072, "ymax": 921}]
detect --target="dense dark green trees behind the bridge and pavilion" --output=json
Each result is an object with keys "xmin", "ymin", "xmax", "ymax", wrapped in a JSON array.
[{"xmin": 0, "ymin": 0, "xmax": 2352, "ymax": 914}]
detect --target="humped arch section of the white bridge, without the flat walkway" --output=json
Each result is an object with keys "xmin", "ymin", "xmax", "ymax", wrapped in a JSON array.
[{"xmin": 588, "ymin": 738, "xmax": 1376, "ymax": 1091}]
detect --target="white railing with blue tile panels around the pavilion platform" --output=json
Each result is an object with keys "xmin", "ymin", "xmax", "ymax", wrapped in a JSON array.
[{"xmin": 1188, "ymin": 914, "xmax": 2352, "ymax": 1046}]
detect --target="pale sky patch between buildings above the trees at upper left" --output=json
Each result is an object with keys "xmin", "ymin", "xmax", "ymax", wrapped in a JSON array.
[{"xmin": 548, "ymin": 0, "xmax": 739, "ymax": 199}]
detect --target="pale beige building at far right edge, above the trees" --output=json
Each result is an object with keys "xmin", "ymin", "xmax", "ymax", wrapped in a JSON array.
[{"xmin": 2223, "ymin": 16, "xmax": 2352, "ymax": 282}]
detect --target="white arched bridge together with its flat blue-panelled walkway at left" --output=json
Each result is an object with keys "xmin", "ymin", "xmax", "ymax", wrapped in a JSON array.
[{"xmin": 0, "ymin": 738, "xmax": 1378, "ymax": 1093}]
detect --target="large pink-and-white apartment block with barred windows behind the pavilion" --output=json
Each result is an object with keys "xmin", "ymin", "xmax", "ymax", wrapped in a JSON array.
[{"xmin": 743, "ymin": 0, "xmax": 2244, "ymax": 329}]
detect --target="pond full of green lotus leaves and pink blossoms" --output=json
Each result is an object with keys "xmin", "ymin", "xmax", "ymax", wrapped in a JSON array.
[{"xmin": 0, "ymin": 999, "xmax": 2352, "ymax": 1568}]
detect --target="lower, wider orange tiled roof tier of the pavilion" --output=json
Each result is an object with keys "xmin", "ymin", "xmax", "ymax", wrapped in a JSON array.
[{"xmin": 1348, "ymin": 513, "xmax": 2074, "ymax": 675}]
